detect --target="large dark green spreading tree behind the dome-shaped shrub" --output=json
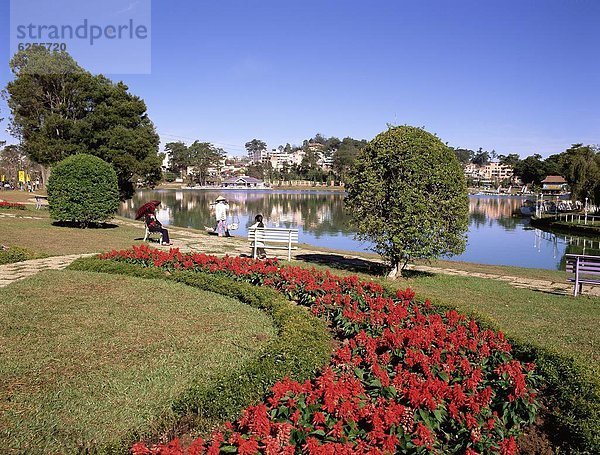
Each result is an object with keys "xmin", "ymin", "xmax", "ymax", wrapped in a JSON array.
[{"xmin": 6, "ymin": 46, "xmax": 162, "ymax": 199}]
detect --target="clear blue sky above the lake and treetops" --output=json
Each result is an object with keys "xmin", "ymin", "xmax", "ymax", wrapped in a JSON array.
[{"xmin": 0, "ymin": 0, "xmax": 600, "ymax": 156}]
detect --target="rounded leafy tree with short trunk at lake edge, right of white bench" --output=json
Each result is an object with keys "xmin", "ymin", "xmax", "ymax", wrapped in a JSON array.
[{"xmin": 346, "ymin": 126, "xmax": 469, "ymax": 277}]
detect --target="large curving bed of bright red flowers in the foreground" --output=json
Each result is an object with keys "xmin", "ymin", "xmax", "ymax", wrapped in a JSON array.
[{"xmin": 101, "ymin": 245, "xmax": 537, "ymax": 455}]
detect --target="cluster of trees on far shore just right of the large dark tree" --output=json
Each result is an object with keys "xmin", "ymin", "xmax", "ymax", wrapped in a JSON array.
[{"xmin": 165, "ymin": 140, "xmax": 225, "ymax": 185}]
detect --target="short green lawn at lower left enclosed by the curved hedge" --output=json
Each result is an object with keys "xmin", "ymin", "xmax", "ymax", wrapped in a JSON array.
[{"xmin": 0, "ymin": 271, "xmax": 275, "ymax": 453}]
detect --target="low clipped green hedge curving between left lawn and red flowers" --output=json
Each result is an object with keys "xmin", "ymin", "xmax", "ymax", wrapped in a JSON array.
[{"xmin": 67, "ymin": 257, "xmax": 334, "ymax": 453}]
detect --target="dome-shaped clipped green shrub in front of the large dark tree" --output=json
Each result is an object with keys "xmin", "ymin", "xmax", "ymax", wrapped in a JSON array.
[{"xmin": 48, "ymin": 153, "xmax": 119, "ymax": 227}]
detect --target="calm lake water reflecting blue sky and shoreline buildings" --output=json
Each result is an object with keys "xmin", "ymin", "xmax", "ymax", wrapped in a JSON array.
[{"xmin": 120, "ymin": 190, "xmax": 600, "ymax": 269}]
